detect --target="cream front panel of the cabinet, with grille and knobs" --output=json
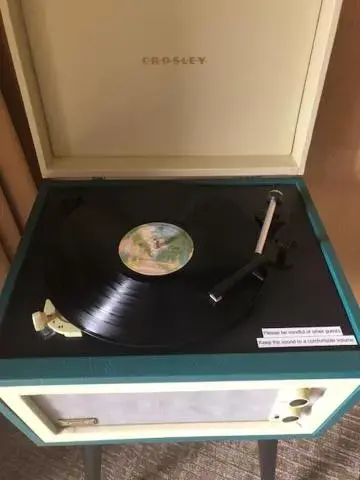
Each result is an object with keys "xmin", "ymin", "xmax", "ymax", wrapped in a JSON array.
[{"xmin": 0, "ymin": 379, "xmax": 359, "ymax": 444}]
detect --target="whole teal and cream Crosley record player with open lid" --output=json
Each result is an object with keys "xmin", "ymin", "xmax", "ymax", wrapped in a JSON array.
[{"xmin": 0, "ymin": 0, "xmax": 360, "ymax": 476}]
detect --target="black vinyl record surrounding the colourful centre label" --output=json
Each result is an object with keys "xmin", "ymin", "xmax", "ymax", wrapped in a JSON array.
[{"xmin": 47, "ymin": 186, "xmax": 262, "ymax": 349}]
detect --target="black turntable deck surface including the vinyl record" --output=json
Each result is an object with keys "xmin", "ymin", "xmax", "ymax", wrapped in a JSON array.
[{"xmin": 0, "ymin": 181, "xmax": 358, "ymax": 358}]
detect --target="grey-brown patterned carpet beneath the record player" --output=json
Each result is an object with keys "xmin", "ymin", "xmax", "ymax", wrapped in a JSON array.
[{"xmin": 0, "ymin": 405, "xmax": 360, "ymax": 480}]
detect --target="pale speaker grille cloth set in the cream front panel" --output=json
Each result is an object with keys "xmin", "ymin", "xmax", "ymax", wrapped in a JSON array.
[{"xmin": 31, "ymin": 390, "xmax": 278, "ymax": 425}]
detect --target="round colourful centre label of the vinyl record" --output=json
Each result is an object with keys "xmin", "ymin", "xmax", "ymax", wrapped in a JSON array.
[{"xmin": 119, "ymin": 222, "xmax": 194, "ymax": 276}]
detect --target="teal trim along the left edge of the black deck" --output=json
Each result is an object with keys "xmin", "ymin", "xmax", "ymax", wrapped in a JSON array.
[{"xmin": 0, "ymin": 184, "xmax": 48, "ymax": 326}]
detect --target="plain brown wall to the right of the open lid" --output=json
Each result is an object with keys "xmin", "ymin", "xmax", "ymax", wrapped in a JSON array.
[{"xmin": 306, "ymin": 0, "xmax": 360, "ymax": 301}]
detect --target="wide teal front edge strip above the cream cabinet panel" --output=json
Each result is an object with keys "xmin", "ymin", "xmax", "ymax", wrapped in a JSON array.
[{"xmin": 0, "ymin": 349, "xmax": 360, "ymax": 386}]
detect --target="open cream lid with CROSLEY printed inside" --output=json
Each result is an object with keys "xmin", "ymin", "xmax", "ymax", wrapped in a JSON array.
[{"xmin": 0, "ymin": 0, "xmax": 341, "ymax": 178}]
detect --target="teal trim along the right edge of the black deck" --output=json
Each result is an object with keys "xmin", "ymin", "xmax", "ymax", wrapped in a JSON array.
[{"xmin": 296, "ymin": 178, "xmax": 360, "ymax": 342}]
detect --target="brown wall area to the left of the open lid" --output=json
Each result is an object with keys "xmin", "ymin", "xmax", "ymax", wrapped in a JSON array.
[{"xmin": 0, "ymin": 18, "xmax": 36, "ymax": 290}]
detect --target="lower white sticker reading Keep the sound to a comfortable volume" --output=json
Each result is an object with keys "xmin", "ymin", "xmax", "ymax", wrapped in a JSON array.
[{"xmin": 256, "ymin": 335, "xmax": 357, "ymax": 348}]
